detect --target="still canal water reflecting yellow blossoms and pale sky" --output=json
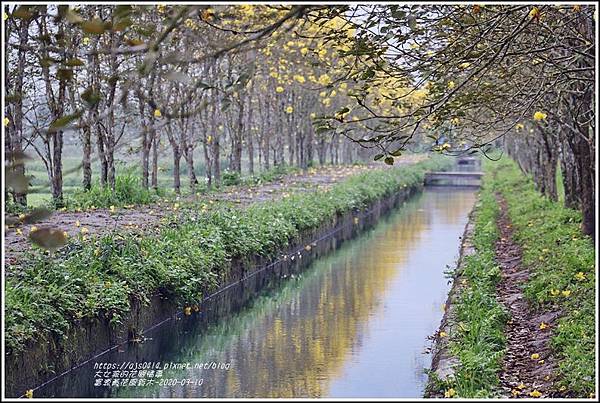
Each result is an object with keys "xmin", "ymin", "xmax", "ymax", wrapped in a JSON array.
[{"xmin": 35, "ymin": 188, "xmax": 476, "ymax": 398}]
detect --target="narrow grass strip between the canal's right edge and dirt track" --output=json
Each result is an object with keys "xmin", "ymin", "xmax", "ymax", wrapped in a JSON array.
[{"xmin": 431, "ymin": 170, "xmax": 508, "ymax": 398}]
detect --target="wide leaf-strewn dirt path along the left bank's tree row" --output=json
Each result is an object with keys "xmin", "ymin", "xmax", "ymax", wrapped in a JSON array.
[{"xmin": 4, "ymin": 155, "xmax": 423, "ymax": 265}]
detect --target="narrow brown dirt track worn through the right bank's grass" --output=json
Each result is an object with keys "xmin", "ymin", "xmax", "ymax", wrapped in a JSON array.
[{"xmin": 496, "ymin": 195, "xmax": 559, "ymax": 398}]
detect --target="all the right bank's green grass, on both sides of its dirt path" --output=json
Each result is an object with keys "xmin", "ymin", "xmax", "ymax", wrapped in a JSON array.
[{"xmin": 430, "ymin": 158, "xmax": 596, "ymax": 398}]
